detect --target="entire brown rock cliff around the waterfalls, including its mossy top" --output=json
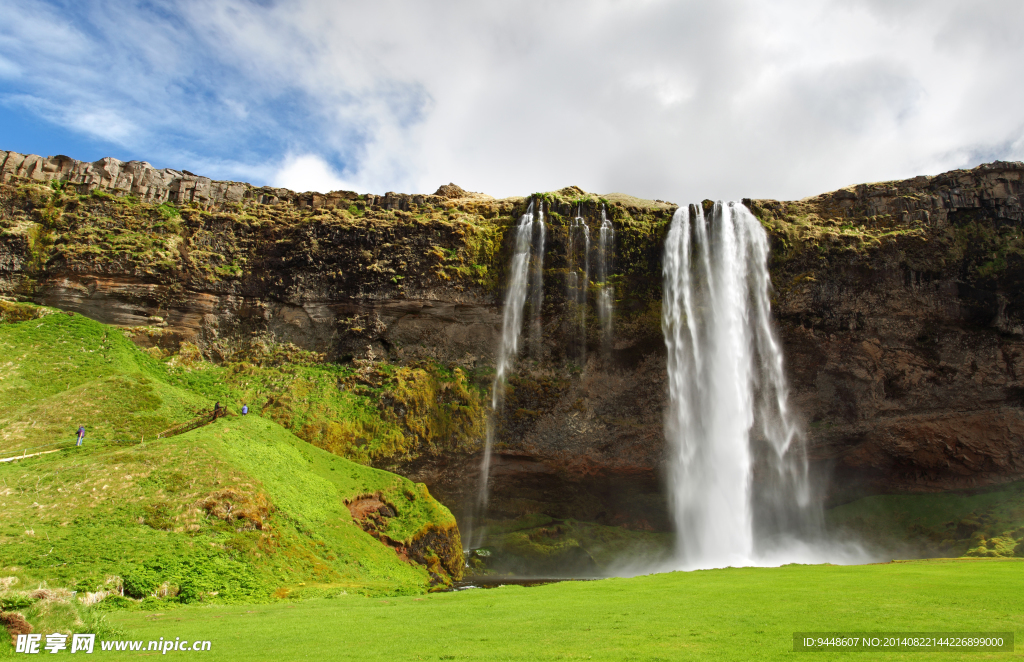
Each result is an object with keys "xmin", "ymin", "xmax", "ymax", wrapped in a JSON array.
[{"xmin": 0, "ymin": 152, "xmax": 1024, "ymax": 530}]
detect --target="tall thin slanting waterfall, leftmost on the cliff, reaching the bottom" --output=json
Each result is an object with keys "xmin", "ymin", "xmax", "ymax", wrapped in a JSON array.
[{"xmin": 465, "ymin": 200, "xmax": 544, "ymax": 547}]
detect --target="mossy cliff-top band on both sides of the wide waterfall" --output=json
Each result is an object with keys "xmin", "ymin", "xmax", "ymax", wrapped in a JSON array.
[{"xmin": 0, "ymin": 157, "xmax": 1024, "ymax": 302}]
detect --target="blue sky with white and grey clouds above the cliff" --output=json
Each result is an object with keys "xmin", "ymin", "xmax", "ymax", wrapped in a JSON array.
[{"xmin": 0, "ymin": 0, "xmax": 1024, "ymax": 203}]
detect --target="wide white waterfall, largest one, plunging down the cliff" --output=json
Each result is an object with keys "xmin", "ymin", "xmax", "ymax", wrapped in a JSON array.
[{"xmin": 663, "ymin": 203, "xmax": 820, "ymax": 568}]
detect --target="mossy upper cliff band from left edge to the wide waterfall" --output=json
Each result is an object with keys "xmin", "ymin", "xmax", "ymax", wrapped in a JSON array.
[{"xmin": 0, "ymin": 171, "xmax": 674, "ymax": 296}]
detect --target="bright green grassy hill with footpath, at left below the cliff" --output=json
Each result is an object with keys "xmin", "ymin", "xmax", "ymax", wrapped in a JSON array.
[{"xmin": 0, "ymin": 314, "xmax": 454, "ymax": 623}]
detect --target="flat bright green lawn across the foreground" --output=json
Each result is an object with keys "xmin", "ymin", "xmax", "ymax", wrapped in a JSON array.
[{"xmin": 81, "ymin": 558, "xmax": 1024, "ymax": 662}]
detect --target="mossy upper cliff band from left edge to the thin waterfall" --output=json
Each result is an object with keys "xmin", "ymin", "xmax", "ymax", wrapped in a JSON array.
[{"xmin": 0, "ymin": 182, "xmax": 520, "ymax": 291}]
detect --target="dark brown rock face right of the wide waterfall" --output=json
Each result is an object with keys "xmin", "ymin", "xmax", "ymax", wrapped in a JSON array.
[{"xmin": 752, "ymin": 163, "xmax": 1024, "ymax": 495}]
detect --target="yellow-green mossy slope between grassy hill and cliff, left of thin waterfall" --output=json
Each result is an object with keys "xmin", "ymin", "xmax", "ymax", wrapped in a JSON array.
[{"xmin": 167, "ymin": 347, "xmax": 485, "ymax": 464}]
